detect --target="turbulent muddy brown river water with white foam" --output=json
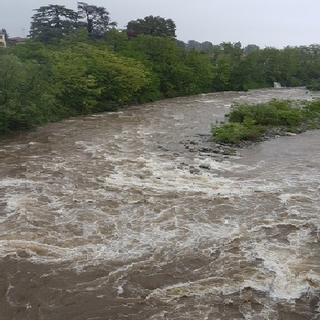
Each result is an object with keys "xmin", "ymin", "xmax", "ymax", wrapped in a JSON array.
[{"xmin": 0, "ymin": 88, "xmax": 320, "ymax": 320}]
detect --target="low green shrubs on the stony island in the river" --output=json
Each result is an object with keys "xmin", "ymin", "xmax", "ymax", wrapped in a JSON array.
[{"xmin": 211, "ymin": 100, "xmax": 320, "ymax": 145}]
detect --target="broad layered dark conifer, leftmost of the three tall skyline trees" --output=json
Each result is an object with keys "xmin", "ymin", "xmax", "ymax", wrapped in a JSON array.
[{"xmin": 29, "ymin": 4, "xmax": 79, "ymax": 44}]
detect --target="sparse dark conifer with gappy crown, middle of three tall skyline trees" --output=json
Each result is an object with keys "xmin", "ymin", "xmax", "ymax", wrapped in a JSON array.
[{"xmin": 78, "ymin": 2, "xmax": 117, "ymax": 38}]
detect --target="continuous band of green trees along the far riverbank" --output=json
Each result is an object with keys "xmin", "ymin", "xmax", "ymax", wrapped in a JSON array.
[{"xmin": 0, "ymin": 2, "xmax": 320, "ymax": 133}]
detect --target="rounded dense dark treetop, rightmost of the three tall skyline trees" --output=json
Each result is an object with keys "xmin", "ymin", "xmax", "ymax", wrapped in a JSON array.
[{"xmin": 127, "ymin": 16, "xmax": 176, "ymax": 38}]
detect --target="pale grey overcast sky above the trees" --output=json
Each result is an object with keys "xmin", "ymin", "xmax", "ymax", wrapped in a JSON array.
[{"xmin": 0, "ymin": 0, "xmax": 320, "ymax": 48}]
